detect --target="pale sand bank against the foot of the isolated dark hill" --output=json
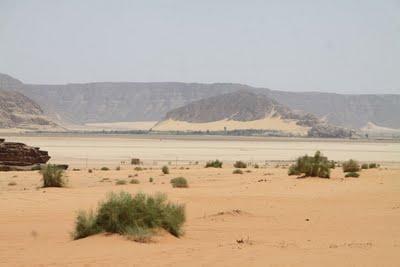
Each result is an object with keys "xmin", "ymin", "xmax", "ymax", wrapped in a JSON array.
[{"xmin": 152, "ymin": 117, "xmax": 309, "ymax": 136}]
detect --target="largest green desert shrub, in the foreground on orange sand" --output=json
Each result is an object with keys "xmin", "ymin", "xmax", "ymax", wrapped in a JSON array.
[{"xmin": 72, "ymin": 192, "xmax": 186, "ymax": 241}]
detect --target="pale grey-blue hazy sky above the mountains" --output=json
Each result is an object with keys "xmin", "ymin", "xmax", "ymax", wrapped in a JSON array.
[{"xmin": 0, "ymin": 0, "xmax": 400, "ymax": 93}]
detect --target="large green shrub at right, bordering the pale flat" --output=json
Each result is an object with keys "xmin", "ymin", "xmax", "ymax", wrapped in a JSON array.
[{"xmin": 288, "ymin": 151, "xmax": 331, "ymax": 178}]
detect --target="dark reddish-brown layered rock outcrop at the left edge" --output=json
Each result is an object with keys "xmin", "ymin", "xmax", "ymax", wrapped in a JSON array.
[{"xmin": 0, "ymin": 139, "xmax": 50, "ymax": 166}]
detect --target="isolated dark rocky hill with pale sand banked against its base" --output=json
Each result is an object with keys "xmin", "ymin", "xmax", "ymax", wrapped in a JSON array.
[{"xmin": 152, "ymin": 91, "xmax": 351, "ymax": 137}]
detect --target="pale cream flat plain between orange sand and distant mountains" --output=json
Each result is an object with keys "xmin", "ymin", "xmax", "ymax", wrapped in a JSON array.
[{"xmin": 3, "ymin": 135, "xmax": 400, "ymax": 167}]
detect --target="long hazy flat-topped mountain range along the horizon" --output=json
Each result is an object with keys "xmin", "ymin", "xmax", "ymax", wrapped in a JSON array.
[{"xmin": 0, "ymin": 75, "xmax": 400, "ymax": 128}]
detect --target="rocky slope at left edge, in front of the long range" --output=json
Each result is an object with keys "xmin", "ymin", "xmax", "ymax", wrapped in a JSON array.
[{"xmin": 0, "ymin": 89, "xmax": 55, "ymax": 128}]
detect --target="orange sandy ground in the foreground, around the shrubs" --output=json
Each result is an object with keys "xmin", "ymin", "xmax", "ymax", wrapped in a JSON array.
[{"xmin": 0, "ymin": 165, "xmax": 400, "ymax": 266}]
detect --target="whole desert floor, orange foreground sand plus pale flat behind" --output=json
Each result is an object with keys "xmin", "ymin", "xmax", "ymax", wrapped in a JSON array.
[{"xmin": 0, "ymin": 136, "xmax": 400, "ymax": 266}]
